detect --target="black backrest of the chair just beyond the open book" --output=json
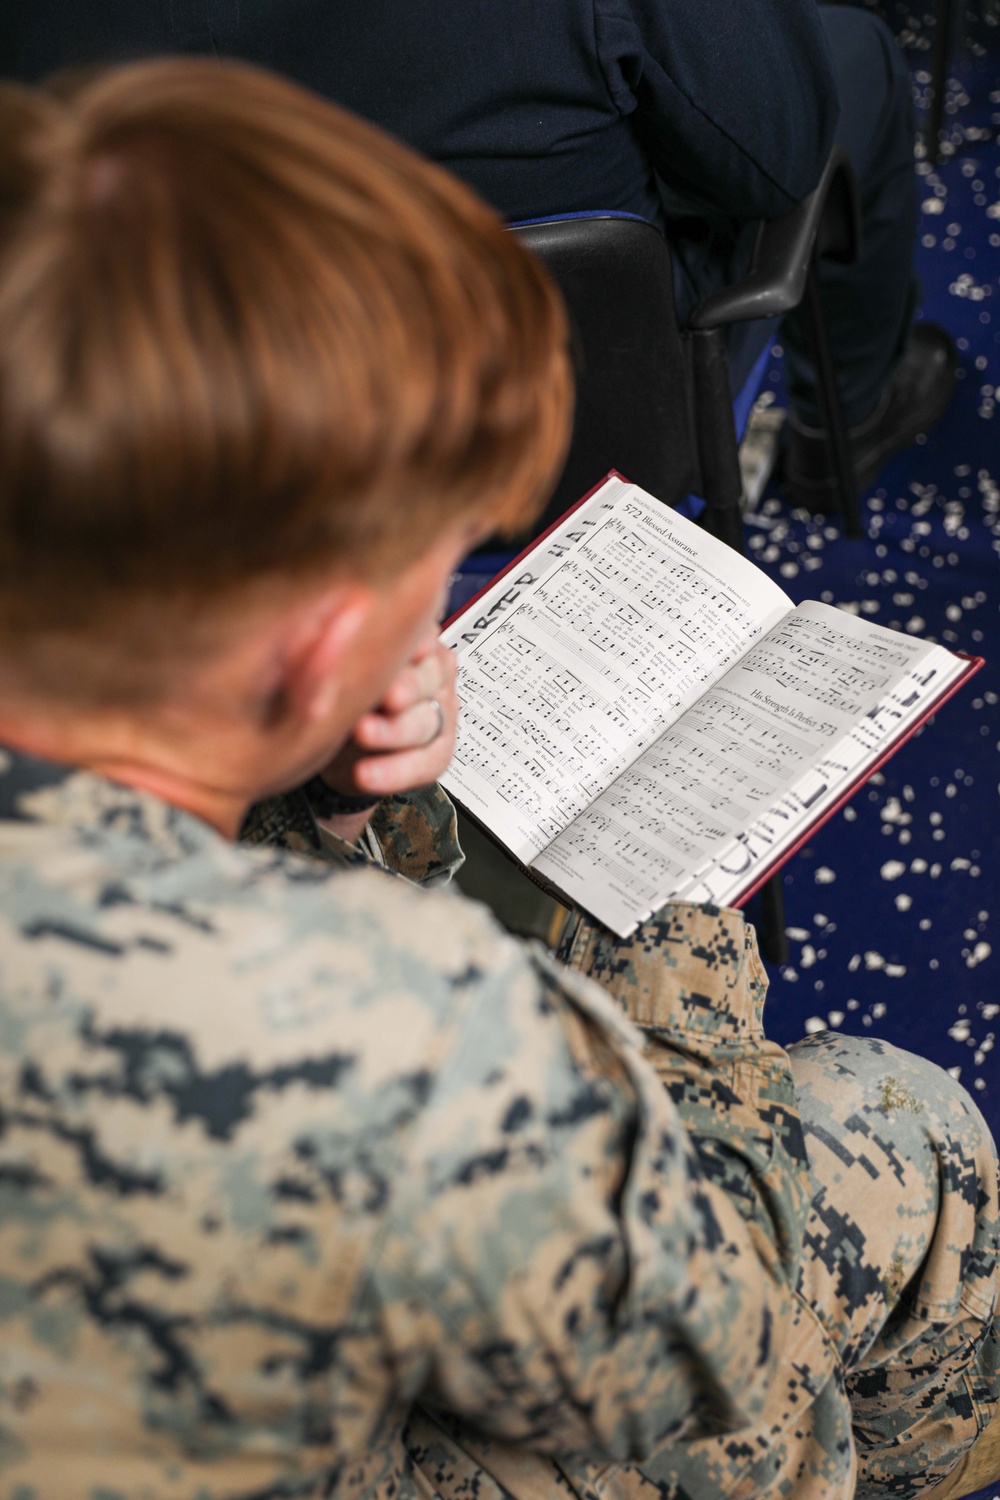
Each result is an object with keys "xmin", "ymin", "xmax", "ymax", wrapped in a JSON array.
[{"xmin": 511, "ymin": 215, "xmax": 697, "ymax": 524}]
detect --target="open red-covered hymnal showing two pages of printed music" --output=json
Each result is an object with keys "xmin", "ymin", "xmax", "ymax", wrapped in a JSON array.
[{"xmin": 442, "ymin": 476, "xmax": 982, "ymax": 936}]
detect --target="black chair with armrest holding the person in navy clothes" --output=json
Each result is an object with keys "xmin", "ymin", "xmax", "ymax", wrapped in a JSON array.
[{"xmin": 514, "ymin": 147, "xmax": 861, "ymax": 552}]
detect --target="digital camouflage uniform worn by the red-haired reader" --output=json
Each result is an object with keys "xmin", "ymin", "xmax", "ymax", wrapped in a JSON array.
[{"xmin": 0, "ymin": 752, "xmax": 1000, "ymax": 1500}]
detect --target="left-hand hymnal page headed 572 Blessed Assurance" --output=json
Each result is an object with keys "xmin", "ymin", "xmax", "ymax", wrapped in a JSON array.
[{"xmin": 442, "ymin": 480, "xmax": 792, "ymax": 864}]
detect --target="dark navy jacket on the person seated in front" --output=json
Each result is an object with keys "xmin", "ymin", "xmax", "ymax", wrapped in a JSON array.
[{"xmin": 7, "ymin": 0, "xmax": 838, "ymax": 227}]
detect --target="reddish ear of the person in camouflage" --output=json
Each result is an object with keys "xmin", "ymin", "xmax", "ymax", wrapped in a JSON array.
[{"xmin": 282, "ymin": 584, "xmax": 378, "ymax": 723}]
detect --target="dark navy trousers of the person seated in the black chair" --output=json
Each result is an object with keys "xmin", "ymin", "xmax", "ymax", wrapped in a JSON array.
[{"xmin": 667, "ymin": 5, "xmax": 919, "ymax": 426}]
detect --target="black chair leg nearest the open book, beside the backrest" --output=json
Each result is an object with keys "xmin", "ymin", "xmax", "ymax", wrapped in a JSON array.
[{"xmin": 685, "ymin": 329, "xmax": 745, "ymax": 554}]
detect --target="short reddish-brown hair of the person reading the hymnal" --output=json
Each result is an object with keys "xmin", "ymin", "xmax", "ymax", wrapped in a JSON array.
[{"xmin": 0, "ymin": 60, "xmax": 570, "ymax": 699}]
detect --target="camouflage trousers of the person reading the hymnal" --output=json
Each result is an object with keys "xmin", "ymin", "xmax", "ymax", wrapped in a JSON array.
[{"xmin": 408, "ymin": 912, "xmax": 1000, "ymax": 1500}]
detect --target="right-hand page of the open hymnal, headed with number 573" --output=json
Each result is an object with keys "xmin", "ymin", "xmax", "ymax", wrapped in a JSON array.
[{"xmin": 532, "ymin": 603, "xmax": 963, "ymax": 936}]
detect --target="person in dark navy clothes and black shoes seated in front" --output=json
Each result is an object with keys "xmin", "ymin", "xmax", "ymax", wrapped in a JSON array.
[{"xmin": 0, "ymin": 0, "xmax": 955, "ymax": 507}]
